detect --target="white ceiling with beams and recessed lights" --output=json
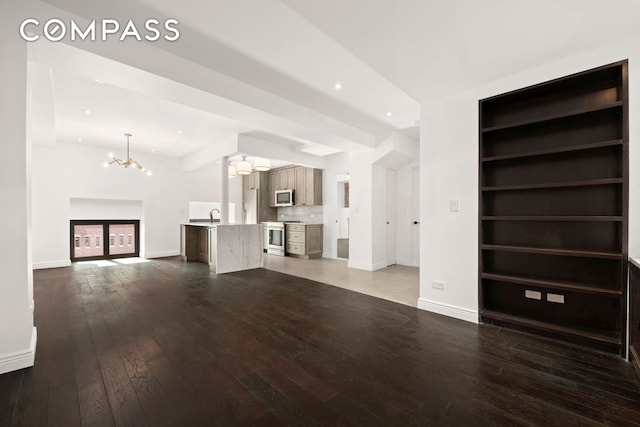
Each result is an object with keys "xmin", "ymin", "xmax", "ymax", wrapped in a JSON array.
[{"xmin": 30, "ymin": 0, "xmax": 640, "ymax": 167}]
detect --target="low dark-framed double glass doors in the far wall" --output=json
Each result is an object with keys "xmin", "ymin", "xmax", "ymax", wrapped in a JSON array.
[{"xmin": 69, "ymin": 219, "xmax": 140, "ymax": 262}]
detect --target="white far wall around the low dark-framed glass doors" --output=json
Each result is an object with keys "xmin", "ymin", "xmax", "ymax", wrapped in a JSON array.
[{"xmin": 33, "ymin": 143, "xmax": 242, "ymax": 268}]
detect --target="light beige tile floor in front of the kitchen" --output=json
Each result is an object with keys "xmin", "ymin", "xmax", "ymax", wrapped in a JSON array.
[{"xmin": 264, "ymin": 254, "xmax": 420, "ymax": 307}]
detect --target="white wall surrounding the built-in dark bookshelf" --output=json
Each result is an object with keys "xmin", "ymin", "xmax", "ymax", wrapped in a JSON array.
[{"xmin": 419, "ymin": 39, "xmax": 640, "ymax": 321}]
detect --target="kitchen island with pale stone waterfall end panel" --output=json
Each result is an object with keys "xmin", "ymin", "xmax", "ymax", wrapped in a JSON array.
[{"xmin": 180, "ymin": 222, "xmax": 263, "ymax": 274}]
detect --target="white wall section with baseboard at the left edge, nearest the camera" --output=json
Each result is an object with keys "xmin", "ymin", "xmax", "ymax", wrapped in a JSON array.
[{"xmin": 0, "ymin": 6, "xmax": 37, "ymax": 374}]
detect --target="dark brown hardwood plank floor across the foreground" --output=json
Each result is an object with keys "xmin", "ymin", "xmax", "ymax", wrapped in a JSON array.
[{"xmin": 0, "ymin": 258, "xmax": 640, "ymax": 427}]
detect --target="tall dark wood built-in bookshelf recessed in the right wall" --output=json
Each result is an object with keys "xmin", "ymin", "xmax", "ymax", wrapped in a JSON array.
[{"xmin": 478, "ymin": 61, "xmax": 629, "ymax": 354}]
